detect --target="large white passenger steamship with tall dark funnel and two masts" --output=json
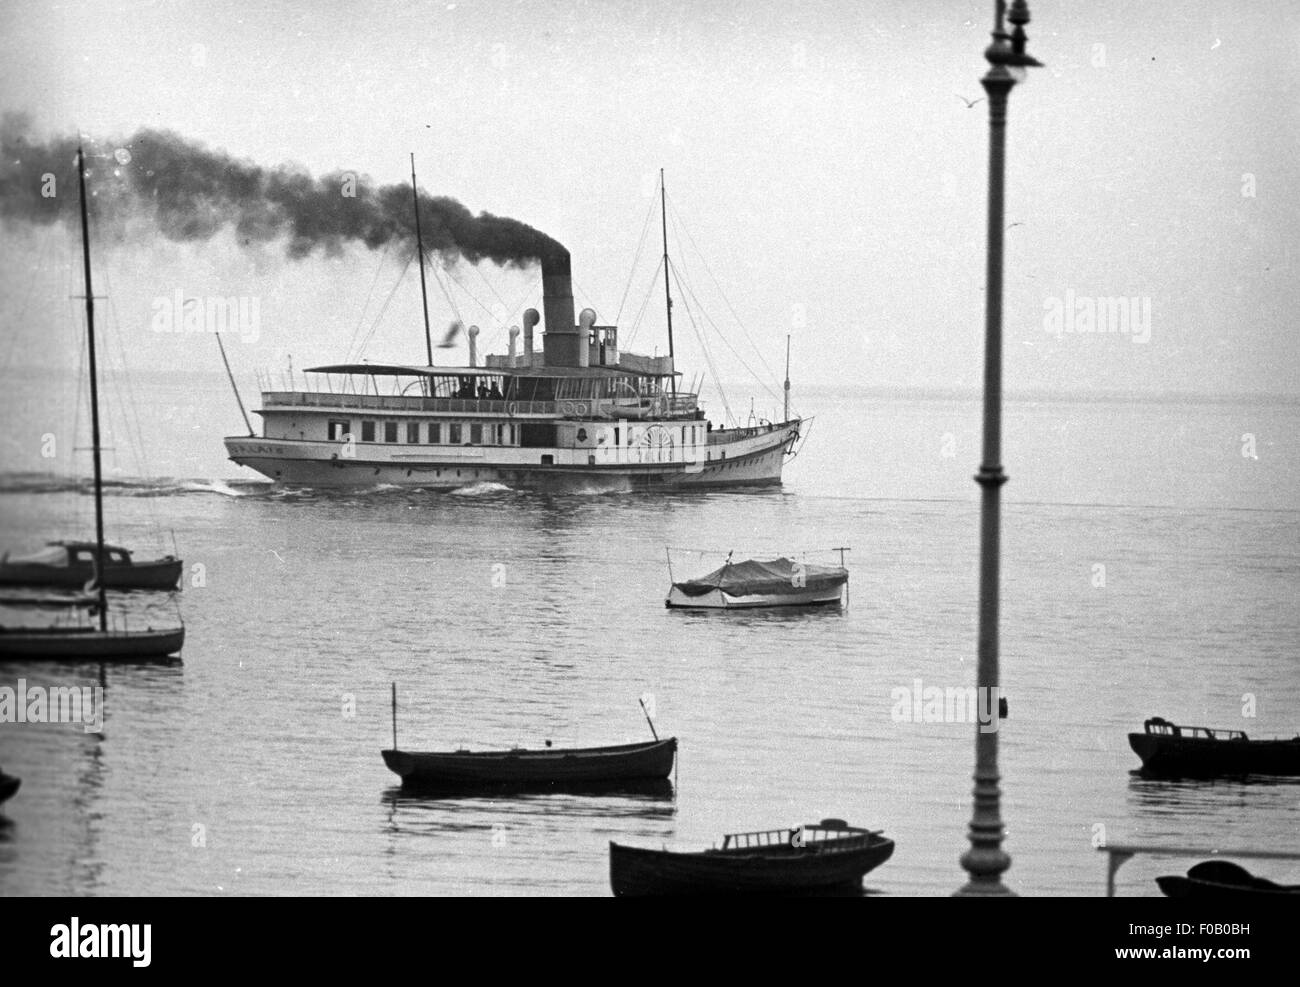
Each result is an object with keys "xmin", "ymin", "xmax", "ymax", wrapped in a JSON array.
[{"xmin": 225, "ymin": 170, "xmax": 802, "ymax": 490}]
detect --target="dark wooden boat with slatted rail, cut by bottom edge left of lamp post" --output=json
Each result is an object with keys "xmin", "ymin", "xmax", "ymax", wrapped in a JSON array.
[{"xmin": 610, "ymin": 819, "xmax": 893, "ymax": 896}]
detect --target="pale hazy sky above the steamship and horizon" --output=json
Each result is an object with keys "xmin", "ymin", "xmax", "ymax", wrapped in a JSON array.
[{"xmin": 0, "ymin": 0, "xmax": 1300, "ymax": 403}]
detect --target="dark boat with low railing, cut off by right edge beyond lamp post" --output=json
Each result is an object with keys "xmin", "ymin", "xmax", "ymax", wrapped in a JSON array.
[{"xmin": 1128, "ymin": 717, "xmax": 1300, "ymax": 778}]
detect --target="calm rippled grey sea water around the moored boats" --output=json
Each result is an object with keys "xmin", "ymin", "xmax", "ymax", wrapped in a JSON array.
[{"xmin": 0, "ymin": 376, "xmax": 1300, "ymax": 895}]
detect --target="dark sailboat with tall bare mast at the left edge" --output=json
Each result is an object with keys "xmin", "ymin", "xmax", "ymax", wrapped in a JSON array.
[{"xmin": 0, "ymin": 147, "xmax": 185, "ymax": 662}]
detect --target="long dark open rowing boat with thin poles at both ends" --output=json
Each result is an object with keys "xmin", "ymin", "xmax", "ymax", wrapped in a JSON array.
[{"xmin": 380, "ymin": 737, "xmax": 677, "ymax": 792}]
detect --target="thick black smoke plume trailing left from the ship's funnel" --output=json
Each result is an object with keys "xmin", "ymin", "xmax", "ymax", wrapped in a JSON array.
[{"xmin": 0, "ymin": 117, "xmax": 568, "ymax": 274}]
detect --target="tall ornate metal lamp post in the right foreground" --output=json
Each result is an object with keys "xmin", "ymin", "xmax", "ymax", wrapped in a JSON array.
[{"xmin": 957, "ymin": 0, "xmax": 1039, "ymax": 896}]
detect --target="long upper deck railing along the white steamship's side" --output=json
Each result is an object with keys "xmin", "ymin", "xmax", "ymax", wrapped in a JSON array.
[{"xmin": 261, "ymin": 390, "xmax": 696, "ymax": 416}]
